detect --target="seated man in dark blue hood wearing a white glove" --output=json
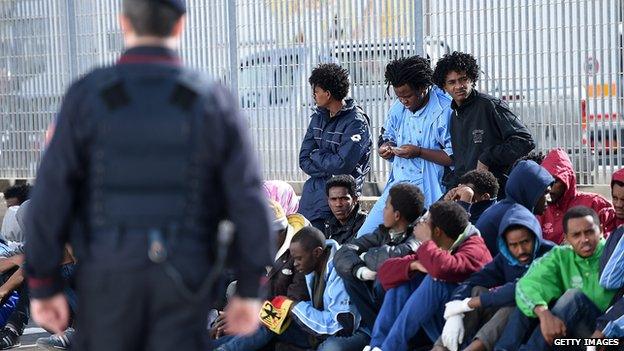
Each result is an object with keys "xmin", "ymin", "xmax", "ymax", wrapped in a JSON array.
[{"xmin": 435, "ymin": 204, "xmax": 554, "ymax": 351}]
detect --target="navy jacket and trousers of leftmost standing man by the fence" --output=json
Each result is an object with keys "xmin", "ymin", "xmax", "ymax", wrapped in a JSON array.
[{"xmin": 299, "ymin": 99, "xmax": 373, "ymax": 221}]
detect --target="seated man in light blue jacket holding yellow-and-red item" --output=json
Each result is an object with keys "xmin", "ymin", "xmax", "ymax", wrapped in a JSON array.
[{"xmin": 216, "ymin": 226, "xmax": 369, "ymax": 351}]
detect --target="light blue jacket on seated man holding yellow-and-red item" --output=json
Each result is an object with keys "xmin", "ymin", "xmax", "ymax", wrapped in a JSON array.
[{"xmin": 292, "ymin": 239, "xmax": 361, "ymax": 337}]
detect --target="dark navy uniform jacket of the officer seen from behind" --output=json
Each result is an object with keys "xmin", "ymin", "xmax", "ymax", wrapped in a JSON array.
[{"xmin": 26, "ymin": 47, "xmax": 273, "ymax": 298}]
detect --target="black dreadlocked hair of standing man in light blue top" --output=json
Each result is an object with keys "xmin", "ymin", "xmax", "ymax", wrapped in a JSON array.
[{"xmin": 385, "ymin": 55, "xmax": 433, "ymax": 95}]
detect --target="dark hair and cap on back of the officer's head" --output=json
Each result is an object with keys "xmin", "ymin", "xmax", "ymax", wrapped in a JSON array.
[{"xmin": 123, "ymin": 0, "xmax": 182, "ymax": 38}]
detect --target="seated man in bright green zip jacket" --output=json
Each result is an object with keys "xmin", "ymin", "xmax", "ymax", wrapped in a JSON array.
[{"xmin": 495, "ymin": 206, "xmax": 615, "ymax": 350}]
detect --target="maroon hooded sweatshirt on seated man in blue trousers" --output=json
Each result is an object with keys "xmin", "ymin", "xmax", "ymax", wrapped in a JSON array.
[{"xmin": 377, "ymin": 224, "xmax": 492, "ymax": 290}]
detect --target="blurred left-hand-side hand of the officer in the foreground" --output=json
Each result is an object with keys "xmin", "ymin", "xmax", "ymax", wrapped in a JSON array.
[{"xmin": 30, "ymin": 293, "xmax": 69, "ymax": 334}]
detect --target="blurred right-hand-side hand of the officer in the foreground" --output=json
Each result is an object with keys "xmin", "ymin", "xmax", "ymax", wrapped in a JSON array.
[{"xmin": 223, "ymin": 296, "xmax": 262, "ymax": 335}]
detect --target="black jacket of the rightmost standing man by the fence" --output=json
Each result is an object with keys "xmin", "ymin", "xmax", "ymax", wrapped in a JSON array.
[{"xmin": 448, "ymin": 89, "xmax": 535, "ymax": 198}]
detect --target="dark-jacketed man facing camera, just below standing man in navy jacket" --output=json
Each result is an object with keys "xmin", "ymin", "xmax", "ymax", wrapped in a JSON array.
[{"xmin": 324, "ymin": 175, "xmax": 366, "ymax": 245}]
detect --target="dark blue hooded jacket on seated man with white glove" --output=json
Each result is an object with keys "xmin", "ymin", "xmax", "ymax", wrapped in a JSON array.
[{"xmin": 451, "ymin": 204, "xmax": 555, "ymax": 308}]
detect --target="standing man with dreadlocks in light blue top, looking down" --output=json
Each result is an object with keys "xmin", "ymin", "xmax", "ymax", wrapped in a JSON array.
[{"xmin": 358, "ymin": 56, "xmax": 453, "ymax": 237}]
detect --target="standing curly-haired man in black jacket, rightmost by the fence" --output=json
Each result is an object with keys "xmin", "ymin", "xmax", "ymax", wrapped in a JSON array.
[{"xmin": 433, "ymin": 51, "xmax": 535, "ymax": 200}]
